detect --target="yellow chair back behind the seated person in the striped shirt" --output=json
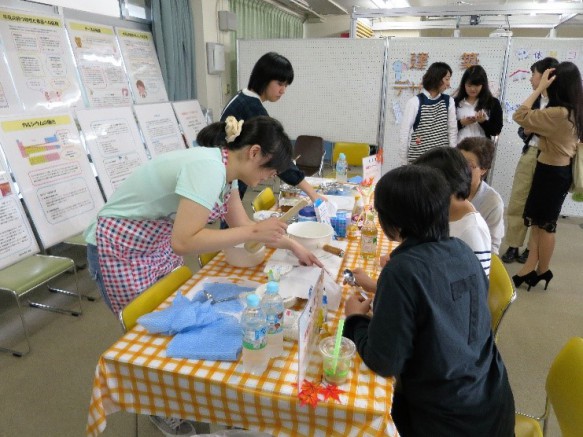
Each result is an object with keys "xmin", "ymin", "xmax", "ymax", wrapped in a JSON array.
[{"xmin": 488, "ymin": 254, "xmax": 516, "ymax": 338}]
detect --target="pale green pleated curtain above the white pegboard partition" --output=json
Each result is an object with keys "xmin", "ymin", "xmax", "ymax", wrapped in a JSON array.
[{"xmin": 229, "ymin": 0, "xmax": 304, "ymax": 95}]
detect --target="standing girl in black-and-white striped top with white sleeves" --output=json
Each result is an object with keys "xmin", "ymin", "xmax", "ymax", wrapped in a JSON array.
[{"xmin": 399, "ymin": 62, "xmax": 457, "ymax": 165}]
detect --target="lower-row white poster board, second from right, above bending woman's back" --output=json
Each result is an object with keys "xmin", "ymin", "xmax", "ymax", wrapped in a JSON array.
[{"xmin": 134, "ymin": 103, "xmax": 185, "ymax": 158}]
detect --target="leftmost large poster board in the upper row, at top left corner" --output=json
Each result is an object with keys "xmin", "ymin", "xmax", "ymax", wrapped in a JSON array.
[{"xmin": 0, "ymin": 9, "xmax": 83, "ymax": 110}]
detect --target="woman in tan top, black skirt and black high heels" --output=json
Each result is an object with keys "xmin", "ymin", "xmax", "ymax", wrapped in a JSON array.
[{"xmin": 512, "ymin": 62, "xmax": 583, "ymax": 290}]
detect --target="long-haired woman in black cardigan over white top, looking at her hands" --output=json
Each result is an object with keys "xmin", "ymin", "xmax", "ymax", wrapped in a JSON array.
[{"xmin": 454, "ymin": 65, "xmax": 503, "ymax": 143}]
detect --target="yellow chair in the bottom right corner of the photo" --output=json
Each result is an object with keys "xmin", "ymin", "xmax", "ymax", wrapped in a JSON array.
[{"xmin": 514, "ymin": 337, "xmax": 583, "ymax": 437}]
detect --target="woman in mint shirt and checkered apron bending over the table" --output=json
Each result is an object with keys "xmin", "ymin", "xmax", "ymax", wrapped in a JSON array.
[{"xmin": 85, "ymin": 117, "xmax": 321, "ymax": 314}]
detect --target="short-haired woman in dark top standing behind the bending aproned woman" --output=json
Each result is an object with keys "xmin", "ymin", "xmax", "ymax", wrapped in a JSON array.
[{"xmin": 221, "ymin": 52, "xmax": 326, "ymax": 201}]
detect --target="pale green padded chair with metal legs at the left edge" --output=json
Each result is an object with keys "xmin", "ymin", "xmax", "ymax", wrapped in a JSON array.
[{"xmin": 0, "ymin": 254, "xmax": 83, "ymax": 357}]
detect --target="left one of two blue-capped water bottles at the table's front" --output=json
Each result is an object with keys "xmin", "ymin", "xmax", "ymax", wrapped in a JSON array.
[{"xmin": 241, "ymin": 294, "xmax": 269, "ymax": 375}]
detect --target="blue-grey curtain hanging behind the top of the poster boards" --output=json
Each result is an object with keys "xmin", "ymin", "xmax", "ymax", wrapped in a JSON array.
[{"xmin": 152, "ymin": 0, "xmax": 196, "ymax": 101}]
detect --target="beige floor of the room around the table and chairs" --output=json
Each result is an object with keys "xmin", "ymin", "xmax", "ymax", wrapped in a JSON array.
[{"xmin": 0, "ymin": 181, "xmax": 583, "ymax": 437}]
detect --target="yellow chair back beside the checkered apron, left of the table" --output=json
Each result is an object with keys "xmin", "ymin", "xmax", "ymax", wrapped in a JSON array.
[{"xmin": 119, "ymin": 266, "xmax": 192, "ymax": 331}]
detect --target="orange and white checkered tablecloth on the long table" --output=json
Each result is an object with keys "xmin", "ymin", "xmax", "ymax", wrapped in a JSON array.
[{"xmin": 87, "ymin": 232, "xmax": 397, "ymax": 437}]
